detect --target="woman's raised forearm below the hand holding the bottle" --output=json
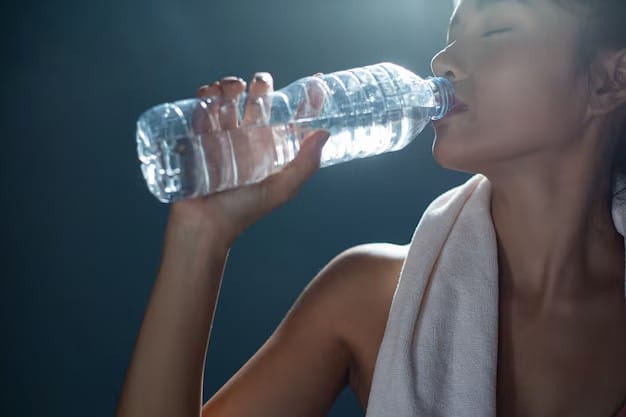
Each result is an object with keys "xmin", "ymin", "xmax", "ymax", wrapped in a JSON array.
[{"xmin": 116, "ymin": 213, "xmax": 228, "ymax": 417}]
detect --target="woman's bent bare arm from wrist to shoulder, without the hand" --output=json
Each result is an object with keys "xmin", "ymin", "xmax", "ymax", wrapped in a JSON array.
[{"xmin": 116, "ymin": 211, "xmax": 360, "ymax": 417}]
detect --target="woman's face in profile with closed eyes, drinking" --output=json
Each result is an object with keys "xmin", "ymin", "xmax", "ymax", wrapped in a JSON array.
[{"xmin": 432, "ymin": 0, "xmax": 587, "ymax": 175}]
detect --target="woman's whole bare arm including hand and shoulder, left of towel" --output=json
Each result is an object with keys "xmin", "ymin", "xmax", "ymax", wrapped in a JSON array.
[{"xmin": 116, "ymin": 74, "xmax": 406, "ymax": 417}]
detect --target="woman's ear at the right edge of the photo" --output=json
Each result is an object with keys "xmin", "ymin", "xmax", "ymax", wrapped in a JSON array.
[{"xmin": 589, "ymin": 49, "xmax": 626, "ymax": 115}]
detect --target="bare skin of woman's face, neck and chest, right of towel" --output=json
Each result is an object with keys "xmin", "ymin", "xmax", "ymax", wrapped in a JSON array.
[{"xmin": 432, "ymin": 0, "xmax": 626, "ymax": 417}]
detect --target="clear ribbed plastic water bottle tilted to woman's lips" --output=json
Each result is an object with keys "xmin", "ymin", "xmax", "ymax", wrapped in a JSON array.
[{"xmin": 137, "ymin": 63, "xmax": 454, "ymax": 202}]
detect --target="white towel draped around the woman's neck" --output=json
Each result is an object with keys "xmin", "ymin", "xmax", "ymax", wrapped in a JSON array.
[{"xmin": 366, "ymin": 174, "xmax": 626, "ymax": 417}]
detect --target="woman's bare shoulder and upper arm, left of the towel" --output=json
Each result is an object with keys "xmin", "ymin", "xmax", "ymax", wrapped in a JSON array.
[{"xmin": 202, "ymin": 243, "xmax": 407, "ymax": 417}]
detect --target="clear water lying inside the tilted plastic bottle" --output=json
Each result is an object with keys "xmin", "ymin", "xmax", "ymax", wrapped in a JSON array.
[{"xmin": 140, "ymin": 107, "xmax": 431, "ymax": 202}]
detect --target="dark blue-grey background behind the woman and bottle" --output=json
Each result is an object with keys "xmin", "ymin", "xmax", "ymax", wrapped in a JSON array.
[{"xmin": 0, "ymin": 0, "xmax": 466, "ymax": 417}]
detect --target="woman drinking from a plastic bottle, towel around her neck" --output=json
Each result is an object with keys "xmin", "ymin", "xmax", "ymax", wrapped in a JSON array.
[{"xmin": 117, "ymin": 0, "xmax": 626, "ymax": 417}]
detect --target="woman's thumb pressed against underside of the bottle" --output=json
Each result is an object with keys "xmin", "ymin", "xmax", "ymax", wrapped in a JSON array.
[{"xmin": 259, "ymin": 130, "xmax": 329, "ymax": 209}]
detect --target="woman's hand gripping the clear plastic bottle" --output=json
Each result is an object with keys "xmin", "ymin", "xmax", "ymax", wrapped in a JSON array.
[{"xmin": 170, "ymin": 73, "xmax": 328, "ymax": 247}]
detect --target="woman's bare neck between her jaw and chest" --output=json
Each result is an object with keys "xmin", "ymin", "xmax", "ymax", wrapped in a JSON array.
[{"xmin": 489, "ymin": 153, "xmax": 624, "ymax": 307}]
